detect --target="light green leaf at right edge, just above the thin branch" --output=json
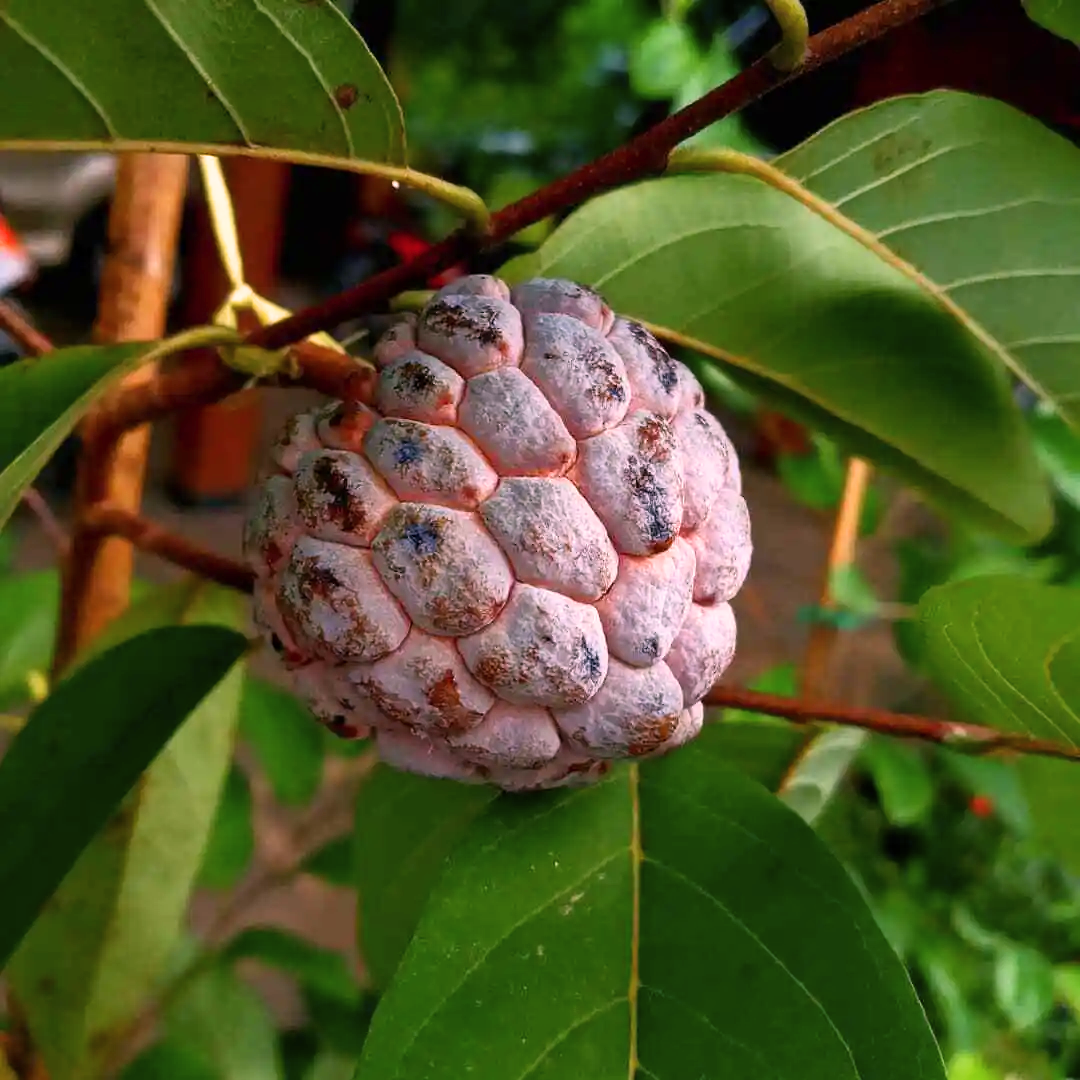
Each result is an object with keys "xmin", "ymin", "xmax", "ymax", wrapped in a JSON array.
[{"xmin": 919, "ymin": 576, "xmax": 1080, "ymax": 745}]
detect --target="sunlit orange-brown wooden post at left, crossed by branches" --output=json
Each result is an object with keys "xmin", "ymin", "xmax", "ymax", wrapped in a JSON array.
[{"xmin": 53, "ymin": 153, "xmax": 188, "ymax": 671}]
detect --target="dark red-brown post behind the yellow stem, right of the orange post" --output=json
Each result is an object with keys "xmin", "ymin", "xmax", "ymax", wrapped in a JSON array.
[{"xmin": 170, "ymin": 158, "xmax": 289, "ymax": 504}]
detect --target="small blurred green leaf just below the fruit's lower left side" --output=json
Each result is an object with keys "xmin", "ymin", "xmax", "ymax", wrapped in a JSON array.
[{"xmin": 240, "ymin": 678, "xmax": 323, "ymax": 806}]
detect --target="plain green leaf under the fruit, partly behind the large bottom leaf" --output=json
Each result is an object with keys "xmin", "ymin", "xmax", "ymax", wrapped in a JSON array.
[{"xmin": 354, "ymin": 765, "xmax": 498, "ymax": 989}]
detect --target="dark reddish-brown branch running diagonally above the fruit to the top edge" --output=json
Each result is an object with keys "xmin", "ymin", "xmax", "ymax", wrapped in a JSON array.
[{"xmin": 249, "ymin": 0, "xmax": 943, "ymax": 349}]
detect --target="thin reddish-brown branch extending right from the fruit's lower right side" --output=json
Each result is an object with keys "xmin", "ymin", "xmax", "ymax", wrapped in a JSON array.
[{"xmin": 705, "ymin": 685, "xmax": 1080, "ymax": 761}]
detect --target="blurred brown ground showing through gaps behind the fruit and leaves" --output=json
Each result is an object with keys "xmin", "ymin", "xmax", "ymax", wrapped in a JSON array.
[{"xmin": 2, "ymin": 285, "xmax": 928, "ymax": 1024}]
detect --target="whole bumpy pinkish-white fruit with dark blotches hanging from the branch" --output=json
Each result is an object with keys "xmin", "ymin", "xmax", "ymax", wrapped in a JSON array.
[{"xmin": 245, "ymin": 274, "xmax": 751, "ymax": 791}]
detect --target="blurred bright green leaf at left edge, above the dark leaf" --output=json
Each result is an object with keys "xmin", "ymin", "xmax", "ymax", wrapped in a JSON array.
[{"xmin": 0, "ymin": 570, "xmax": 60, "ymax": 702}]
